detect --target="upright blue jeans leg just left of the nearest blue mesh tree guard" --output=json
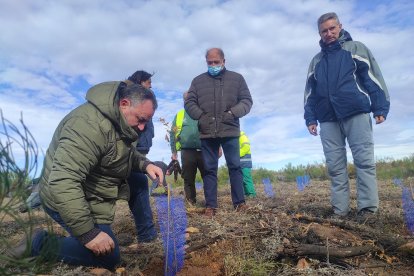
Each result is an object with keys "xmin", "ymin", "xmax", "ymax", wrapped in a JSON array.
[{"xmin": 128, "ymin": 173, "xmax": 157, "ymax": 242}]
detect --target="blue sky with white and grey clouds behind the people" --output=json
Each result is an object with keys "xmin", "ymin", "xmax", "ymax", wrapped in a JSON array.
[{"xmin": 0, "ymin": 0, "xmax": 414, "ymax": 174}]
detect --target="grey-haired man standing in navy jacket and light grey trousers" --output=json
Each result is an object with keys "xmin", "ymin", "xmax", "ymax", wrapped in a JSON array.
[{"xmin": 304, "ymin": 12, "xmax": 390, "ymax": 222}]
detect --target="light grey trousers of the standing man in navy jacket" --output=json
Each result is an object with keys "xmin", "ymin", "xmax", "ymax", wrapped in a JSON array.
[{"xmin": 320, "ymin": 113, "xmax": 379, "ymax": 215}]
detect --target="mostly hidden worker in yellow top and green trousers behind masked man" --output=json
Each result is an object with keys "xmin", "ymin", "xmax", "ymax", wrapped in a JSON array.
[{"xmin": 239, "ymin": 131, "xmax": 256, "ymax": 197}]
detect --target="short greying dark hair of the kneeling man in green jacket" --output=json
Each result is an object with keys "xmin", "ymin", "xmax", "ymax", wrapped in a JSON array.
[{"xmin": 118, "ymin": 82, "xmax": 158, "ymax": 110}]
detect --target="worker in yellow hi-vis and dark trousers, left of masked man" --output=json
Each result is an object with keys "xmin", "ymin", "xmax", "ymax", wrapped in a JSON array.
[{"xmin": 170, "ymin": 92, "xmax": 204, "ymax": 204}]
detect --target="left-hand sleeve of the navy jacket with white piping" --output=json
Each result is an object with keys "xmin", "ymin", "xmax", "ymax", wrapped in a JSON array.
[{"xmin": 304, "ymin": 62, "xmax": 318, "ymax": 126}]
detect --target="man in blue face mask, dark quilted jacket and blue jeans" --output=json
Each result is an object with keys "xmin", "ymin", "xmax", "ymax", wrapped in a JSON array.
[{"xmin": 184, "ymin": 48, "xmax": 253, "ymax": 218}]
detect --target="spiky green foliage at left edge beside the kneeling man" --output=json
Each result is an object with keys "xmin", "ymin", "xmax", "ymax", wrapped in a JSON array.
[{"xmin": 0, "ymin": 110, "xmax": 56, "ymax": 275}]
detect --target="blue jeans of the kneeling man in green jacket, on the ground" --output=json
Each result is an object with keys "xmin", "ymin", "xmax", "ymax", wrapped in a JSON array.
[{"xmin": 31, "ymin": 206, "xmax": 121, "ymax": 270}]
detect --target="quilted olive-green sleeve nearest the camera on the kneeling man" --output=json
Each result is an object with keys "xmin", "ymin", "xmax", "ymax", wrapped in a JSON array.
[{"xmin": 48, "ymin": 117, "xmax": 108, "ymax": 236}]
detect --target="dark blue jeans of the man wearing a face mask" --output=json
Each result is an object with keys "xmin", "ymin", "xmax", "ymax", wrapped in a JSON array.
[{"xmin": 201, "ymin": 137, "xmax": 245, "ymax": 208}]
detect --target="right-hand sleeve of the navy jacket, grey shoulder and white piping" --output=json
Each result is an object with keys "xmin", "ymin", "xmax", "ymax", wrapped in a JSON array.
[{"xmin": 353, "ymin": 42, "xmax": 390, "ymax": 118}]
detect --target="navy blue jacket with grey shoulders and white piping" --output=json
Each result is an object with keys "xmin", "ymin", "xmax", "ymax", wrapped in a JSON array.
[{"xmin": 304, "ymin": 30, "xmax": 390, "ymax": 126}]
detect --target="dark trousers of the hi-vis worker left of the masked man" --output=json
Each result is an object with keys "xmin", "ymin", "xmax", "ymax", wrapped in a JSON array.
[{"xmin": 181, "ymin": 149, "xmax": 205, "ymax": 203}]
